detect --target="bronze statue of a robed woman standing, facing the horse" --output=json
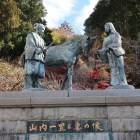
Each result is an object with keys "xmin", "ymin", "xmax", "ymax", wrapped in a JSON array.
[{"xmin": 97, "ymin": 22, "xmax": 135, "ymax": 88}]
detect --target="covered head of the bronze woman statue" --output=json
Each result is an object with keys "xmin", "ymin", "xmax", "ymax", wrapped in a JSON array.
[{"xmin": 104, "ymin": 22, "xmax": 116, "ymax": 34}]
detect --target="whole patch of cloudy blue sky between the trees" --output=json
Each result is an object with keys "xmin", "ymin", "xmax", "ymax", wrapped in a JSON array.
[{"xmin": 43, "ymin": 0, "xmax": 99, "ymax": 34}]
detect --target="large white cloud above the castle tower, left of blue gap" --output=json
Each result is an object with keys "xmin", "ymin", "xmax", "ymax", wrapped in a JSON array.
[{"xmin": 43, "ymin": 0, "xmax": 77, "ymax": 28}]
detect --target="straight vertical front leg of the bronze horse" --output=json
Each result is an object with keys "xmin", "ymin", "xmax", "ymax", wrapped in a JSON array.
[{"xmin": 67, "ymin": 65, "xmax": 73, "ymax": 90}]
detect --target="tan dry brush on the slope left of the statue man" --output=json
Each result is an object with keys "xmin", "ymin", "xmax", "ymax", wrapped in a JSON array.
[{"xmin": 0, "ymin": 60, "xmax": 23, "ymax": 91}]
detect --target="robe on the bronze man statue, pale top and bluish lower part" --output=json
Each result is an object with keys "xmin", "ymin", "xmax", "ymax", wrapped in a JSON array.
[{"xmin": 24, "ymin": 32, "xmax": 45, "ymax": 78}]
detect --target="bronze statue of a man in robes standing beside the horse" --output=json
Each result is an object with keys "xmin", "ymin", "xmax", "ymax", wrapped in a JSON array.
[{"xmin": 24, "ymin": 23, "xmax": 45, "ymax": 89}]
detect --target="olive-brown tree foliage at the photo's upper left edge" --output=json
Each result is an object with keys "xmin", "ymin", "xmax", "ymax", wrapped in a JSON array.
[{"xmin": 0, "ymin": 0, "xmax": 20, "ymax": 47}]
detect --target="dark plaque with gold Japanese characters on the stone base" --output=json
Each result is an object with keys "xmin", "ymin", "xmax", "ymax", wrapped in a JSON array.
[{"xmin": 27, "ymin": 120, "xmax": 112, "ymax": 133}]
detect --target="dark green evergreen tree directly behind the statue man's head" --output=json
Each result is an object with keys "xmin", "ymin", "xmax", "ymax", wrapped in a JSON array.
[{"xmin": 2, "ymin": 0, "xmax": 46, "ymax": 58}]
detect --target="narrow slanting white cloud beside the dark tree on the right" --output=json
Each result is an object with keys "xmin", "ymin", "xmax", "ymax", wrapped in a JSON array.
[{"xmin": 74, "ymin": 0, "xmax": 99, "ymax": 34}]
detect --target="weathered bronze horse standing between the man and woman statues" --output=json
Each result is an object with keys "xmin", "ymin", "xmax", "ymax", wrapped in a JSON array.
[{"xmin": 45, "ymin": 35, "xmax": 95, "ymax": 90}]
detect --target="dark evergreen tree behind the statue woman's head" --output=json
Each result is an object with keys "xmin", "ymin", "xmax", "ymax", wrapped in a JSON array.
[{"xmin": 84, "ymin": 0, "xmax": 140, "ymax": 38}]
